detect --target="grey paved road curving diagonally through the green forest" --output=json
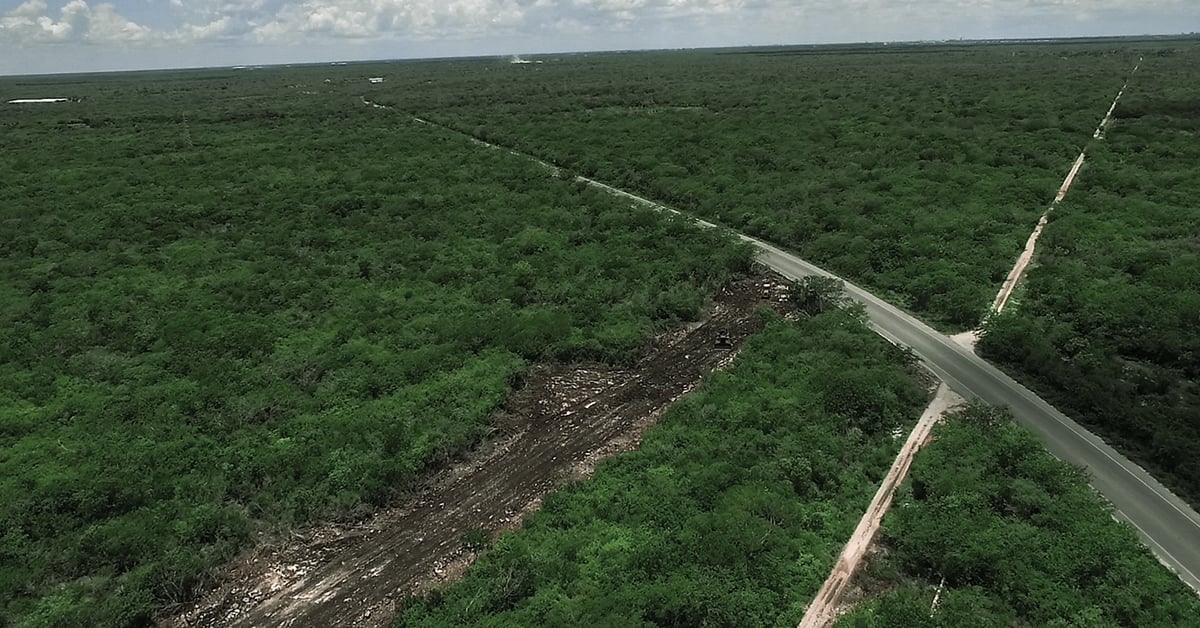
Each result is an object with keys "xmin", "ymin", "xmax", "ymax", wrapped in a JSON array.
[{"xmin": 366, "ymin": 101, "xmax": 1200, "ymax": 592}]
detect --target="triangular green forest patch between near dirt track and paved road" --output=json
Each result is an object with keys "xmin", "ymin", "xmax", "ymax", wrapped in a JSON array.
[{"xmin": 838, "ymin": 406, "xmax": 1200, "ymax": 628}]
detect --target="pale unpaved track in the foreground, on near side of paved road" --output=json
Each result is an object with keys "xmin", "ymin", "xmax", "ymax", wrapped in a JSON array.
[{"xmin": 799, "ymin": 383, "xmax": 962, "ymax": 628}]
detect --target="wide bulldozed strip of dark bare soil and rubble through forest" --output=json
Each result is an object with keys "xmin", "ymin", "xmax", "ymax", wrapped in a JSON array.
[{"xmin": 158, "ymin": 276, "xmax": 786, "ymax": 627}]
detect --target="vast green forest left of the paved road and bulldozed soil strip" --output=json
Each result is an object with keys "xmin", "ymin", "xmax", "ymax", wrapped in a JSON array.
[{"xmin": 0, "ymin": 70, "xmax": 750, "ymax": 627}]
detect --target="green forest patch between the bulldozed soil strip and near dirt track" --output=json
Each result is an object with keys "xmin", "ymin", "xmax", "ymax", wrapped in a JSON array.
[{"xmin": 396, "ymin": 310, "xmax": 925, "ymax": 627}]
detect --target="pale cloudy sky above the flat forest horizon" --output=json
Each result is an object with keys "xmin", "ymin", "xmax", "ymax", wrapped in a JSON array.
[{"xmin": 0, "ymin": 0, "xmax": 1200, "ymax": 74}]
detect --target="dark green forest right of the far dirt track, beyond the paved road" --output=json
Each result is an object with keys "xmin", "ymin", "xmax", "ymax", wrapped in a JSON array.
[{"xmin": 979, "ymin": 48, "xmax": 1200, "ymax": 506}]
